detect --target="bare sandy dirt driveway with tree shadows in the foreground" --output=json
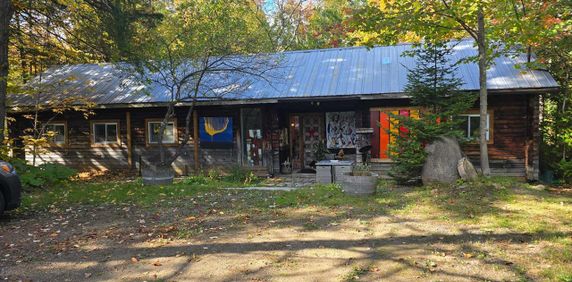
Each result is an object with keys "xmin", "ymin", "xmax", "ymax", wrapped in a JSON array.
[{"xmin": 0, "ymin": 198, "xmax": 539, "ymax": 281}]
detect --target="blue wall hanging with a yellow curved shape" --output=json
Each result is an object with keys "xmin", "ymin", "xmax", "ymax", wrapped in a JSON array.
[{"xmin": 199, "ymin": 117, "xmax": 233, "ymax": 145}]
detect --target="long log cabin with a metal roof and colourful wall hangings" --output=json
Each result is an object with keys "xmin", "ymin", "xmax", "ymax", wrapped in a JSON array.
[{"xmin": 10, "ymin": 40, "xmax": 558, "ymax": 179}]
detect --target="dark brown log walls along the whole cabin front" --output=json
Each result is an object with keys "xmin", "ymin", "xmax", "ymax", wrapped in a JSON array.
[{"xmin": 10, "ymin": 94, "xmax": 539, "ymax": 179}]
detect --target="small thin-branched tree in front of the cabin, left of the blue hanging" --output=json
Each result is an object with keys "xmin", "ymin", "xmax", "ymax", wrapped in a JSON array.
[{"xmin": 128, "ymin": 0, "xmax": 279, "ymax": 167}]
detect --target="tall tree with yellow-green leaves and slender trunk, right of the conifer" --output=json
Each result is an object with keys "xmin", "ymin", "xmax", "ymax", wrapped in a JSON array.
[{"xmin": 351, "ymin": 0, "xmax": 572, "ymax": 174}]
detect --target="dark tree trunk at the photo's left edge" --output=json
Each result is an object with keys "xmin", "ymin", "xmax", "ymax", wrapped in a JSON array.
[{"xmin": 0, "ymin": 0, "xmax": 14, "ymax": 142}]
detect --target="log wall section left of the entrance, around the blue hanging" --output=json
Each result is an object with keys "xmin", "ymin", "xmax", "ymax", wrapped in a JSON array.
[{"xmin": 12, "ymin": 107, "xmax": 240, "ymax": 174}]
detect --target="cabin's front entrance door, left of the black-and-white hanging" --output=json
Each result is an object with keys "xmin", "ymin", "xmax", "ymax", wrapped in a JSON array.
[{"xmin": 290, "ymin": 113, "xmax": 325, "ymax": 170}]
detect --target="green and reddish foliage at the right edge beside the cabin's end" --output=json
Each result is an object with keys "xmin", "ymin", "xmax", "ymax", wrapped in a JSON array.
[{"xmin": 530, "ymin": 1, "xmax": 572, "ymax": 182}]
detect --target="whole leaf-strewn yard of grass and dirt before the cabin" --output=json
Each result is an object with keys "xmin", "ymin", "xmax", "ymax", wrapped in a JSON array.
[{"xmin": 0, "ymin": 177, "xmax": 572, "ymax": 281}]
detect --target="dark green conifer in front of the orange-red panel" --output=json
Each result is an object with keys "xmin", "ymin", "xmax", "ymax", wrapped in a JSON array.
[{"xmin": 389, "ymin": 42, "xmax": 476, "ymax": 183}]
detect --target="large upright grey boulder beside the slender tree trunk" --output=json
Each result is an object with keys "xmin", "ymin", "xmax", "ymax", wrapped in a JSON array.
[{"xmin": 421, "ymin": 137, "xmax": 463, "ymax": 184}]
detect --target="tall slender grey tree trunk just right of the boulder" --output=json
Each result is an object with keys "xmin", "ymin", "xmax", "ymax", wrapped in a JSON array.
[{"xmin": 477, "ymin": 7, "xmax": 491, "ymax": 176}]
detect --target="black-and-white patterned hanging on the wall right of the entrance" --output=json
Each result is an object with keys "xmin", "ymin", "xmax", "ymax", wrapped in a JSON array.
[{"xmin": 326, "ymin": 112, "xmax": 356, "ymax": 149}]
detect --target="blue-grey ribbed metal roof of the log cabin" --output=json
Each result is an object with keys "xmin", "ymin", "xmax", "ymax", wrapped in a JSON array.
[{"xmin": 12, "ymin": 40, "xmax": 558, "ymax": 105}]
